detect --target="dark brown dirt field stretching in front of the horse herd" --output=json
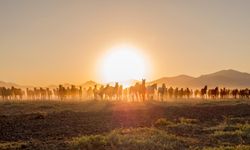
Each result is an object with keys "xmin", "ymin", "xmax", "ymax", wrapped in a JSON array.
[{"xmin": 0, "ymin": 100, "xmax": 250, "ymax": 149}]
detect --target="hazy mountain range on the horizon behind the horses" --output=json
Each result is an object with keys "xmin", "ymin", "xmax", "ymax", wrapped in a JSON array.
[{"xmin": 0, "ymin": 69, "xmax": 250, "ymax": 88}]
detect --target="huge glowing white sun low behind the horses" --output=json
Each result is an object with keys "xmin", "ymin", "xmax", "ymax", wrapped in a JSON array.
[{"xmin": 101, "ymin": 45, "xmax": 146, "ymax": 84}]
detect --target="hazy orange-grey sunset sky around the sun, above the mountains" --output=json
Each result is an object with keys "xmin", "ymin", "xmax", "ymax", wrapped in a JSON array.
[{"xmin": 0, "ymin": 0, "xmax": 250, "ymax": 85}]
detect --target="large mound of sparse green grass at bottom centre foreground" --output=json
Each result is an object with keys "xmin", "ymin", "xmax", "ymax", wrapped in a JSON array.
[{"xmin": 71, "ymin": 128, "xmax": 191, "ymax": 150}]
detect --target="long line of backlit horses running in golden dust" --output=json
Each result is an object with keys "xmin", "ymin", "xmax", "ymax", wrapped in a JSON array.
[{"xmin": 0, "ymin": 79, "xmax": 250, "ymax": 101}]
